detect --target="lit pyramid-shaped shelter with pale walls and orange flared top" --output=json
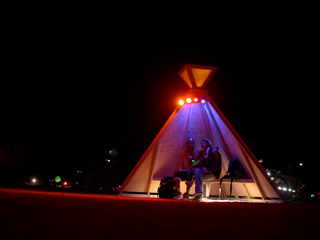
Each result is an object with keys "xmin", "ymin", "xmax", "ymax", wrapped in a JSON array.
[{"xmin": 119, "ymin": 64, "xmax": 284, "ymax": 202}]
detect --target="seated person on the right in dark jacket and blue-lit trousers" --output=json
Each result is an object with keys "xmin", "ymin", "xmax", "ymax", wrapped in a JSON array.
[{"xmin": 193, "ymin": 139, "xmax": 221, "ymax": 201}]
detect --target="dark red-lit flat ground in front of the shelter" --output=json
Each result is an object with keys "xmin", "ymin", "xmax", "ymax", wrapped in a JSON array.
[{"xmin": 0, "ymin": 188, "xmax": 320, "ymax": 240}]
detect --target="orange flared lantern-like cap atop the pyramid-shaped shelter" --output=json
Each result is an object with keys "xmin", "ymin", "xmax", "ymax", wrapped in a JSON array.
[{"xmin": 178, "ymin": 64, "xmax": 218, "ymax": 89}]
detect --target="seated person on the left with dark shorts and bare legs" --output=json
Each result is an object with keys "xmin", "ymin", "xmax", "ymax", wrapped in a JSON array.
[{"xmin": 173, "ymin": 138, "xmax": 202, "ymax": 200}]
